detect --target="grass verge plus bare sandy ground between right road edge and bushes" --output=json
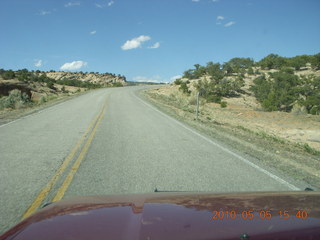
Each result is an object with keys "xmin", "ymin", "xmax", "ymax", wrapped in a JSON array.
[{"xmin": 139, "ymin": 85, "xmax": 320, "ymax": 190}]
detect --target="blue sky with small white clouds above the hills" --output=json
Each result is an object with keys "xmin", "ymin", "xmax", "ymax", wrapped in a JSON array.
[{"xmin": 0, "ymin": 0, "xmax": 320, "ymax": 82}]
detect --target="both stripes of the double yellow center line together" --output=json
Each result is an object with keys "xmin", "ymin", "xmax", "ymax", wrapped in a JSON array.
[{"xmin": 22, "ymin": 98, "xmax": 107, "ymax": 219}]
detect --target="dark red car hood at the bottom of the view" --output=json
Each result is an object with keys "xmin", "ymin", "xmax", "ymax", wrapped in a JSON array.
[{"xmin": 0, "ymin": 192, "xmax": 320, "ymax": 240}]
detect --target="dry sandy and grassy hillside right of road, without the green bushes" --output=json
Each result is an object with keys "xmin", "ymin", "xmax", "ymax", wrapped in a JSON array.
[{"xmin": 143, "ymin": 54, "xmax": 320, "ymax": 188}]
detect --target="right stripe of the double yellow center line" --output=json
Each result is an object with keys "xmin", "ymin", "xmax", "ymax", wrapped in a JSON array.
[{"xmin": 52, "ymin": 100, "xmax": 105, "ymax": 202}]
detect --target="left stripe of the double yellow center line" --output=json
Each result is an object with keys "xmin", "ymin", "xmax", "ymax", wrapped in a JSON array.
[{"xmin": 22, "ymin": 99, "xmax": 106, "ymax": 219}]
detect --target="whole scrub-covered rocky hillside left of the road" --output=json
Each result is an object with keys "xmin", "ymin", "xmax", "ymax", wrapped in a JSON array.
[{"xmin": 0, "ymin": 69, "xmax": 128, "ymax": 110}]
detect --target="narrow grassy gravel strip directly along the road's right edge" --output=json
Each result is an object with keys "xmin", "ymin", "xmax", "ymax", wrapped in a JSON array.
[{"xmin": 137, "ymin": 88, "xmax": 320, "ymax": 190}]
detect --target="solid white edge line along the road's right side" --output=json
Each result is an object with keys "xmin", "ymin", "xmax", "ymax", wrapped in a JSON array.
[{"xmin": 135, "ymin": 95, "xmax": 301, "ymax": 191}]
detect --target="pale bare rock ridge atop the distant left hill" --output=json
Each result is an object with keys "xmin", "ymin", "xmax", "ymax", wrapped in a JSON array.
[{"xmin": 45, "ymin": 71, "xmax": 127, "ymax": 86}]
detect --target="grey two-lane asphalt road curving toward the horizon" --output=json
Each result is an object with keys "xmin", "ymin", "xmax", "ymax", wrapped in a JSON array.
[{"xmin": 0, "ymin": 87, "xmax": 298, "ymax": 232}]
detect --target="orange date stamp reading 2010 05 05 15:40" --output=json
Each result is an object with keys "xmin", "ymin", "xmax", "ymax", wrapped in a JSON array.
[{"xmin": 212, "ymin": 210, "xmax": 308, "ymax": 220}]
